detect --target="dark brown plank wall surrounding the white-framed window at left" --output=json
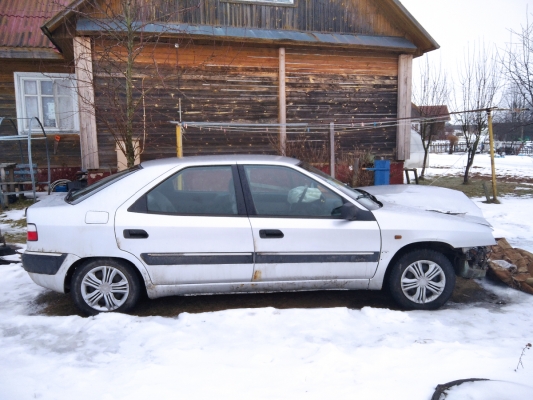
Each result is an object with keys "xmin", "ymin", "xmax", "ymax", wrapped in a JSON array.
[{"xmin": 0, "ymin": 60, "xmax": 81, "ymax": 168}]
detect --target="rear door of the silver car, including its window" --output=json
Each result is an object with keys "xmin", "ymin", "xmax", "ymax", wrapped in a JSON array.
[{"xmin": 115, "ymin": 165, "xmax": 254, "ymax": 285}]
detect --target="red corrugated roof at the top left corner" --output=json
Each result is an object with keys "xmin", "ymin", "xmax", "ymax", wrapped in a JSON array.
[{"xmin": 0, "ymin": 0, "xmax": 70, "ymax": 49}]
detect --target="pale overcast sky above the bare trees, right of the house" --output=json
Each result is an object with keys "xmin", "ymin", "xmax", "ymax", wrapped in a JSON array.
[{"xmin": 400, "ymin": 0, "xmax": 533, "ymax": 100}]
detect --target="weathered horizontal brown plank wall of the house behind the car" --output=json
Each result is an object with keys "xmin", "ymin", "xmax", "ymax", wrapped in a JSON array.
[{"xmin": 94, "ymin": 40, "xmax": 398, "ymax": 166}]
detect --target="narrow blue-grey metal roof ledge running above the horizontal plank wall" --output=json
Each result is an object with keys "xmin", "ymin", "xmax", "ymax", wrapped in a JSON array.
[{"xmin": 76, "ymin": 19, "xmax": 417, "ymax": 52}]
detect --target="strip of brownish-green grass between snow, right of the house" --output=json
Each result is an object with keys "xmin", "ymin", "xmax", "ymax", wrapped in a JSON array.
[{"xmin": 420, "ymin": 176, "xmax": 533, "ymax": 197}]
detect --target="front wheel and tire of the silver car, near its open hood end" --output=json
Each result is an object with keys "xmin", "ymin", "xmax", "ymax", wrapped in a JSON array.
[{"xmin": 388, "ymin": 250, "xmax": 455, "ymax": 310}]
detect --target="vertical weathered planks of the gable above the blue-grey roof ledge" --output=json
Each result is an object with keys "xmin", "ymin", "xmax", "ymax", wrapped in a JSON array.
[{"xmin": 139, "ymin": 0, "xmax": 404, "ymax": 36}]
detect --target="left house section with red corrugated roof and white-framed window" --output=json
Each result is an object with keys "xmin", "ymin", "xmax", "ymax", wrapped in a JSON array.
[{"xmin": 0, "ymin": 0, "xmax": 81, "ymax": 179}]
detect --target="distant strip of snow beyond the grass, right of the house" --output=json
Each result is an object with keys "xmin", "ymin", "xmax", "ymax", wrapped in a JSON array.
[{"xmin": 426, "ymin": 153, "xmax": 533, "ymax": 178}]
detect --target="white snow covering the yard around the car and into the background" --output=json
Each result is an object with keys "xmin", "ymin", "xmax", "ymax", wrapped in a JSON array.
[{"xmin": 0, "ymin": 155, "xmax": 533, "ymax": 400}]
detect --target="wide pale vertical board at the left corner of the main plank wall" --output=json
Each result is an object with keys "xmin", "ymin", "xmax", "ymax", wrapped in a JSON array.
[{"xmin": 74, "ymin": 36, "xmax": 100, "ymax": 169}]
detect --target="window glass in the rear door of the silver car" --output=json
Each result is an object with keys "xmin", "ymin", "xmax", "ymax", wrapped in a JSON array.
[{"xmin": 146, "ymin": 166, "xmax": 237, "ymax": 215}]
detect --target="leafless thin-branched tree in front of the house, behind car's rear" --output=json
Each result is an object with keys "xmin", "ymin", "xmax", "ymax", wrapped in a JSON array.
[{"xmin": 63, "ymin": 0, "xmax": 194, "ymax": 167}]
